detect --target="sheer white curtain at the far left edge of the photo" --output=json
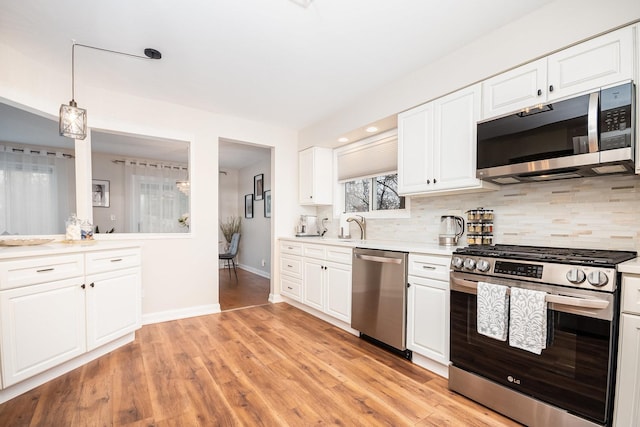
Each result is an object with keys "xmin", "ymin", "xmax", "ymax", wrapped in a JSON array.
[{"xmin": 0, "ymin": 145, "xmax": 76, "ymax": 235}]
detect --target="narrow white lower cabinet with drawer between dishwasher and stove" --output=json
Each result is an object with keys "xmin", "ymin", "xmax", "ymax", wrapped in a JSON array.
[{"xmin": 407, "ymin": 253, "xmax": 450, "ymax": 373}]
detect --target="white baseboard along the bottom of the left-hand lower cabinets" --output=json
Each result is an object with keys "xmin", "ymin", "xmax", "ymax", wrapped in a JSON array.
[{"xmin": 0, "ymin": 332, "xmax": 135, "ymax": 403}]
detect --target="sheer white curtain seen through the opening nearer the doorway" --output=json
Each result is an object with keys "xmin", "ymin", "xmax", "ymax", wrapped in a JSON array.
[{"xmin": 124, "ymin": 160, "xmax": 189, "ymax": 233}]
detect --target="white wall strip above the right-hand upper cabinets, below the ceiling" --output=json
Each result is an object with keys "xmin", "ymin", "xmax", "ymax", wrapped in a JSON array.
[{"xmin": 299, "ymin": 0, "xmax": 640, "ymax": 149}]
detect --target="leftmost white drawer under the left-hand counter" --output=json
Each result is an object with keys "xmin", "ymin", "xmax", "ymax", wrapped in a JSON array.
[{"xmin": 0, "ymin": 254, "xmax": 84, "ymax": 289}]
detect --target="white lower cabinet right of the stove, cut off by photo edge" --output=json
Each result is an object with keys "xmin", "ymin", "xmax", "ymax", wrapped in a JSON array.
[{"xmin": 614, "ymin": 274, "xmax": 640, "ymax": 427}]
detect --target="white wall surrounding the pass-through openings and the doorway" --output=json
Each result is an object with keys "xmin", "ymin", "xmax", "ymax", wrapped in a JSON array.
[{"xmin": 0, "ymin": 43, "xmax": 297, "ymax": 322}]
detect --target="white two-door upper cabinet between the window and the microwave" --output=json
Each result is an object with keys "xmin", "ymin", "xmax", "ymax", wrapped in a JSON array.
[{"xmin": 398, "ymin": 84, "xmax": 495, "ymax": 195}]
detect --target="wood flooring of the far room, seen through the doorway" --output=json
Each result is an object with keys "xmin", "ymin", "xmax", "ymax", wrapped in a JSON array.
[{"xmin": 218, "ymin": 268, "xmax": 271, "ymax": 311}]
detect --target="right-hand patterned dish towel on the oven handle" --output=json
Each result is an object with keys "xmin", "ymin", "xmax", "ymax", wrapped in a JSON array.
[{"xmin": 509, "ymin": 288, "xmax": 547, "ymax": 354}]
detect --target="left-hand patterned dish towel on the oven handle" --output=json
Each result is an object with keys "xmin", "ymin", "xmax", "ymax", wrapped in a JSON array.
[{"xmin": 477, "ymin": 282, "xmax": 509, "ymax": 341}]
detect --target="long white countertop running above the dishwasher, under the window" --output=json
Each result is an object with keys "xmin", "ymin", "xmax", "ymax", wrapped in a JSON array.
[{"xmin": 280, "ymin": 237, "xmax": 458, "ymax": 256}]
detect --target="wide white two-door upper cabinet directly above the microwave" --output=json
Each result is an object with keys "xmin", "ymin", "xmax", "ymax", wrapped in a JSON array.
[{"xmin": 482, "ymin": 27, "xmax": 634, "ymax": 119}]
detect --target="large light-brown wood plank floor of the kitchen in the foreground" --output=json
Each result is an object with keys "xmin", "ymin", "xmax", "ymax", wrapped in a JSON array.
[{"xmin": 0, "ymin": 303, "xmax": 518, "ymax": 427}]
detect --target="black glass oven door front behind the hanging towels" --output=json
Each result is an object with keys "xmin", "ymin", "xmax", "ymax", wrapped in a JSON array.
[{"xmin": 451, "ymin": 291, "xmax": 612, "ymax": 423}]
